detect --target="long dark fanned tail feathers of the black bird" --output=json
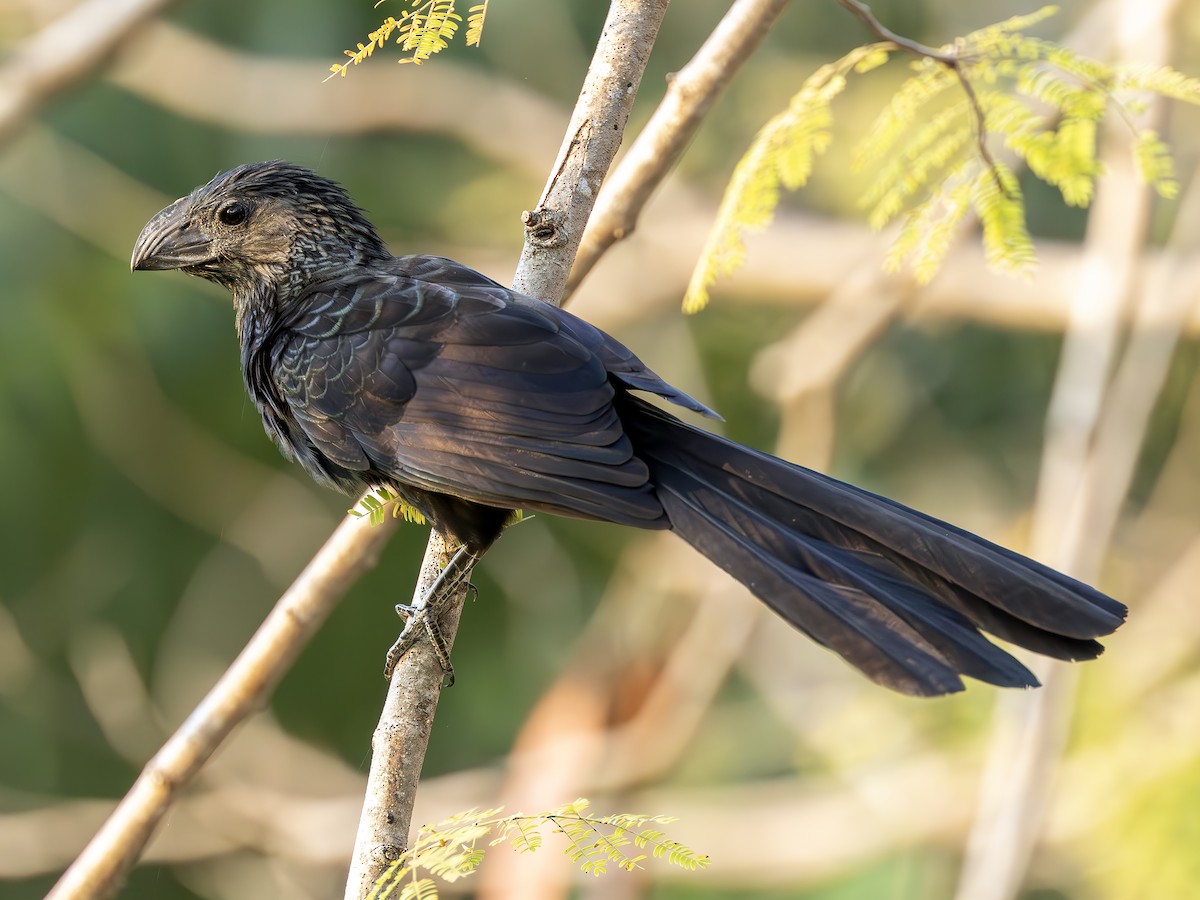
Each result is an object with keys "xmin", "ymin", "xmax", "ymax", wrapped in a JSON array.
[{"xmin": 622, "ymin": 396, "xmax": 1126, "ymax": 695}]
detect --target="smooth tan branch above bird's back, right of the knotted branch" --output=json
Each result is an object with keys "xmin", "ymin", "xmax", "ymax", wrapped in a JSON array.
[{"xmin": 566, "ymin": 0, "xmax": 787, "ymax": 296}]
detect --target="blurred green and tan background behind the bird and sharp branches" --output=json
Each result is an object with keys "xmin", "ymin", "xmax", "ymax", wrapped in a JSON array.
[{"xmin": 0, "ymin": 0, "xmax": 1200, "ymax": 900}]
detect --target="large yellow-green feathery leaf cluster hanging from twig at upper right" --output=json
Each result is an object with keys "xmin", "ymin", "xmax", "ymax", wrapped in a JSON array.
[{"xmin": 684, "ymin": 6, "xmax": 1200, "ymax": 312}]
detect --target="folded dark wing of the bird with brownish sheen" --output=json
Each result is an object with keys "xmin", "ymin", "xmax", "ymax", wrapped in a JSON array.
[{"xmin": 274, "ymin": 264, "xmax": 662, "ymax": 526}]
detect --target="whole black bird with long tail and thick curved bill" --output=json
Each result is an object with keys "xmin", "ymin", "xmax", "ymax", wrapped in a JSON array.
[{"xmin": 132, "ymin": 162, "xmax": 1126, "ymax": 695}]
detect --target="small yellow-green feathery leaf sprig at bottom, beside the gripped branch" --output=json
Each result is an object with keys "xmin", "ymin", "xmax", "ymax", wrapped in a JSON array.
[{"xmin": 368, "ymin": 799, "xmax": 708, "ymax": 900}]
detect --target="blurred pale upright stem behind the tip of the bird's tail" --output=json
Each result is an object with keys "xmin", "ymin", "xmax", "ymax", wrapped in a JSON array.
[{"xmin": 956, "ymin": 0, "xmax": 1175, "ymax": 900}]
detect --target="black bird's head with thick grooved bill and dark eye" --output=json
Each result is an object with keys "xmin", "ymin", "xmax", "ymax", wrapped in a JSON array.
[{"xmin": 130, "ymin": 161, "xmax": 388, "ymax": 299}]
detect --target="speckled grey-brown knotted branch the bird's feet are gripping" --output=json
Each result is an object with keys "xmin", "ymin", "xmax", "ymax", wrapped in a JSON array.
[{"xmin": 346, "ymin": 0, "xmax": 667, "ymax": 900}]
